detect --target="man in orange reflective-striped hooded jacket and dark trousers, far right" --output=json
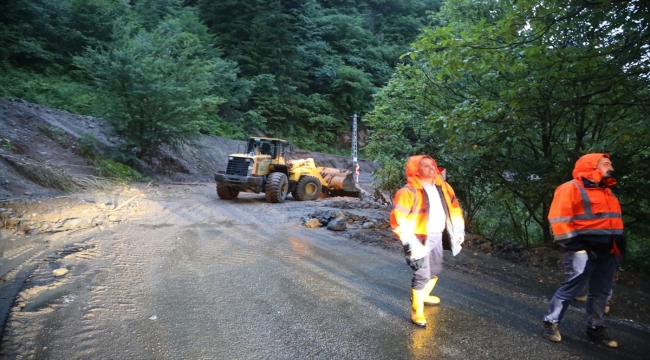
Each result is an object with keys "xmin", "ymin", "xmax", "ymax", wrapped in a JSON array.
[{"xmin": 544, "ymin": 153, "xmax": 625, "ymax": 348}]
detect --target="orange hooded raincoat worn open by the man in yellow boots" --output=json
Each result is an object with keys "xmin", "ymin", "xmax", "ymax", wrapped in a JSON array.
[{"xmin": 390, "ymin": 155, "xmax": 465, "ymax": 255}]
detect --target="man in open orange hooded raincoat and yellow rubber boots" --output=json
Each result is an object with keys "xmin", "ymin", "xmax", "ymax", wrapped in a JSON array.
[{"xmin": 390, "ymin": 155, "xmax": 465, "ymax": 326}]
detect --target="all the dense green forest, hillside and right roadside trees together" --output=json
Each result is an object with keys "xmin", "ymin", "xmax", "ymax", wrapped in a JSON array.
[{"xmin": 0, "ymin": 0, "xmax": 650, "ymax": 271}]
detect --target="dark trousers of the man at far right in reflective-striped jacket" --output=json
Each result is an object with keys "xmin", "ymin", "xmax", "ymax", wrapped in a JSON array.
[{"xmin": 544, "ymin": 250, "xmax": 618, "ymax": 326}]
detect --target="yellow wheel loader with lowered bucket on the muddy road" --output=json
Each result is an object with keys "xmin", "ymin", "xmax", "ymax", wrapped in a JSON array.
[{"xmin": 214, "ymin": 137, "xmax": 360, "ymax": 203}]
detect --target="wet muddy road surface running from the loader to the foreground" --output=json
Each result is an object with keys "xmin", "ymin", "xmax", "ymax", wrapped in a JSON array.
[{"xmin": 0, "ymin": 184, "xmax": 650, "ymax": 359}]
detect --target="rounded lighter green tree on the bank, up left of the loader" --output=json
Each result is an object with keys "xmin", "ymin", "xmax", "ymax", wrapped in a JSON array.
[{"xmin": 76, "ymin": 19, "xmax": 243, "ymax": 157}]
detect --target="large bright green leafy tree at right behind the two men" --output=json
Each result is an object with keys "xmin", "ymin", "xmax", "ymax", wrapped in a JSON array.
[{"xmin": 370, "ymin": 0, "xmax": 650, "ymax": 270}]
